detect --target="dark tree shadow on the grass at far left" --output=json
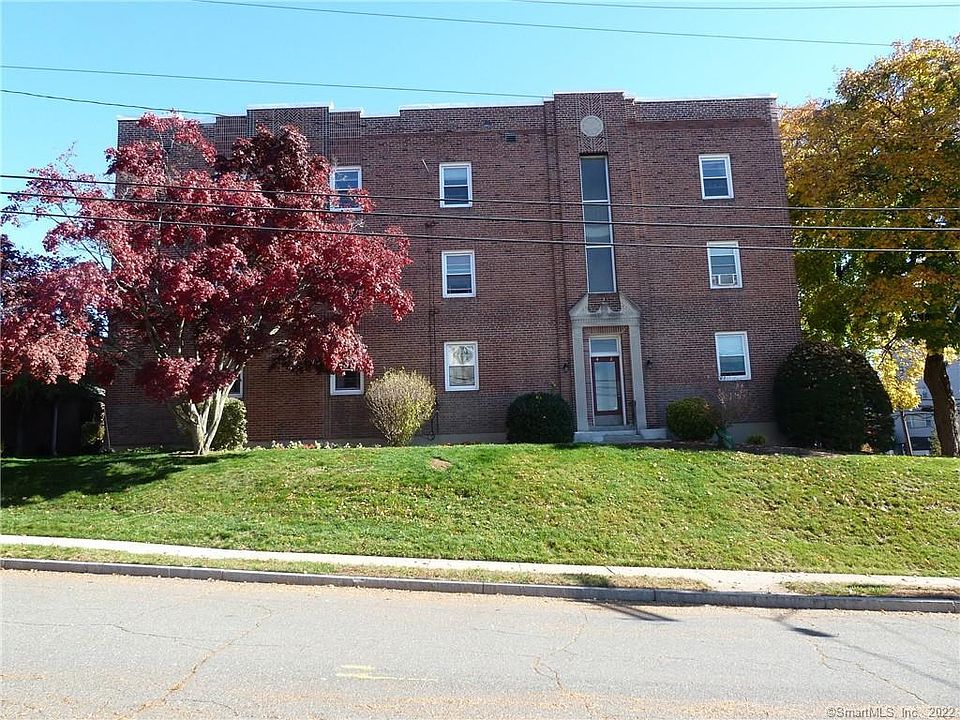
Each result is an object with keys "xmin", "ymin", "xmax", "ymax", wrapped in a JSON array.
[{"xmin": 0, "ymin": 453, "xmax": 230, "ymax": 507}]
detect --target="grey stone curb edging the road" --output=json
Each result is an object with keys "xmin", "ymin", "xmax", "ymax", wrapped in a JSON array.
[{"xmin": 0, "ymin": 558, "xmax": 960, "ymax": 613}]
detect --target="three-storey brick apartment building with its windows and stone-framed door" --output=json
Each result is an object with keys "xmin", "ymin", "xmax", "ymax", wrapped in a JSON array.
[{"xmin": 107, "ymin": 92, "xmax": 800, "ymax": 446}]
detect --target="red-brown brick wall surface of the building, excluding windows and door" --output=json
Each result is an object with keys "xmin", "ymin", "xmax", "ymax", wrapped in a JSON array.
[{"xmin": 108, "ymin": 93, "xmax": 799, "ymax": 444}]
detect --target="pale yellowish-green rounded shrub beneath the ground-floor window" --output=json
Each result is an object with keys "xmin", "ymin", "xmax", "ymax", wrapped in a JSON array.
[{"xmin": 366, "ymin": 368, "xmax": 437, "ymax": 447}]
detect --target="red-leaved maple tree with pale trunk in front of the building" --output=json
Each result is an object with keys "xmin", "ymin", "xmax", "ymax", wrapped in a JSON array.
[{"xmin": 2, "ymin": 114, "xmax": 413, "ymax": 454}]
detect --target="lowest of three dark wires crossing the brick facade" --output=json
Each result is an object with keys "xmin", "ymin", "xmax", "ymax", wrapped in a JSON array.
[{"xmin": 6, "ymin": 210, "xmax": 960, "ymax": 254}]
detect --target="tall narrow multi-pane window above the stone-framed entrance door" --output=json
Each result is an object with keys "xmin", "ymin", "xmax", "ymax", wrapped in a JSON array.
[{"xmin": 580, "ymin": 155, "xmax": 617, "ymax": 293}]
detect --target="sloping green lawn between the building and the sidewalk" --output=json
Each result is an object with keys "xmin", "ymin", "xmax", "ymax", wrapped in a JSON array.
[{"xmin": 2, "ymin": 445, "xmax": 960, "ymax": 575}]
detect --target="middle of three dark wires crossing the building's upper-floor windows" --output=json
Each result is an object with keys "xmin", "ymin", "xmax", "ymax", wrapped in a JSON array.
[{"xmin": 9, "ymin": 191, "xmax": 960, "ymax": 232}]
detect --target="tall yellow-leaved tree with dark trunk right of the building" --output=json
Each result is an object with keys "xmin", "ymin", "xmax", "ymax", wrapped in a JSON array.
[{"xmin": 781, "ymin": 36, "xmax": 960, "ymax": 457}]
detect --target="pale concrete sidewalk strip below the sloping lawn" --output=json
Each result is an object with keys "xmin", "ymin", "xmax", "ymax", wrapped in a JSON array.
[{"xmin": 0, "ymin": 535, "xmax": 960, "ymax": 594}]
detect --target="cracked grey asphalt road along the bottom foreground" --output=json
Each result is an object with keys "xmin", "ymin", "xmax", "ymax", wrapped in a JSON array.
[{"xmin": 0, "ymin": 571, "xmax": 960, "ymax": 720}]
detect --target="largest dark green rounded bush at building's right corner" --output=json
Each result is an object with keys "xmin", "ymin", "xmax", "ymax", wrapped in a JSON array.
[{"xmin": 773, "ymin": 342, "xmax": 893, "ymax": 452}]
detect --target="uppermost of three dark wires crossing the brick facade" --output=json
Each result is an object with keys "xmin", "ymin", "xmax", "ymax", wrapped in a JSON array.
[{"xmin": 0, "ymin": 173, "xmax": 960, "ymax": 214}]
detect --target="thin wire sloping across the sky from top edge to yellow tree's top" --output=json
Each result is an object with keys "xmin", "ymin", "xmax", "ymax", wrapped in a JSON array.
[{"xmin": 191, "ymin": 0, "xmax": 890, "ymax": 48}]
